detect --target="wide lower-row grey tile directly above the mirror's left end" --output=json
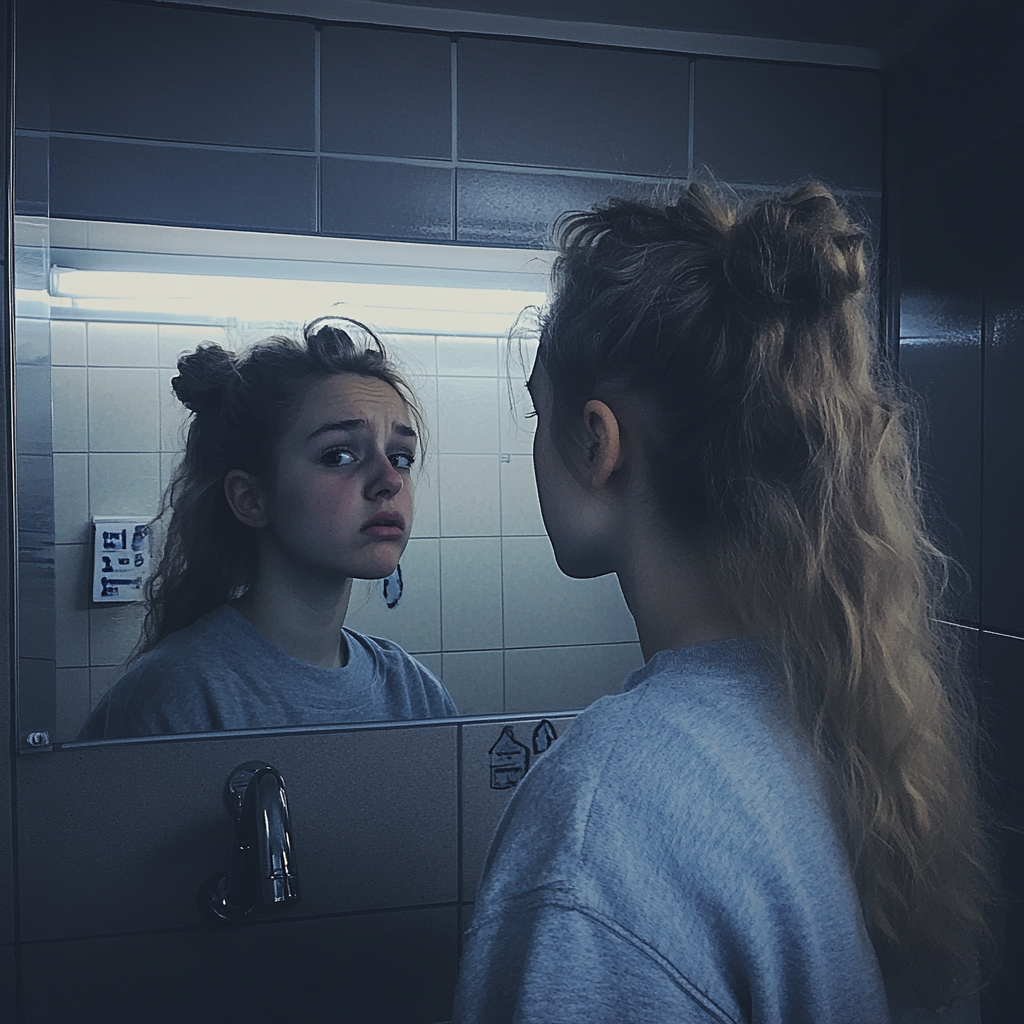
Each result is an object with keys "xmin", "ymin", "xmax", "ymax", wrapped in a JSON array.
[{"xmin": 50, "ymin": 138, "xmax": 316, "ymax": 232}]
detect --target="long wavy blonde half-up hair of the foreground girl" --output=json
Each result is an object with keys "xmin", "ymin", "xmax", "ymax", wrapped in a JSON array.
[{"xmin": 538, "ymin": 184, "xmax": 999, "ymax": 1008}]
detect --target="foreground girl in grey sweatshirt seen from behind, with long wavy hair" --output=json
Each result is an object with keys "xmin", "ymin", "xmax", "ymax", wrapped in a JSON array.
[{"xmin": 455, "ymin": 185, "xmax": 997, "ymax": 1024}]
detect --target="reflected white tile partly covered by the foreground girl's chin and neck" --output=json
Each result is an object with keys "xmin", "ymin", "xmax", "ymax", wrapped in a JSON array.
[{"xmin": 502, "ymin": 537, "xmax": 637, "ymax": 647}]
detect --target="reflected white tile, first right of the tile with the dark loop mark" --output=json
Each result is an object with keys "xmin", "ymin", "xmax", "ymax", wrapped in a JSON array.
[{"xmin": 441, "ymin": 538, "xmax": 504, "ymax": 651}]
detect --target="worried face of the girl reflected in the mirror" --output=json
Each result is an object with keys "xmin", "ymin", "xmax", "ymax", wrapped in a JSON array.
[{"xmin": 266, "ymin": 374, "xmax": 417, "ymax": 580}]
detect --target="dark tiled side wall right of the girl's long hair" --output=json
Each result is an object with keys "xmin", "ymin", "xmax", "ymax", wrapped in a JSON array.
[{"xmin": 886, "ymin": 0, "xmax": 1024, "ymax": 1022}]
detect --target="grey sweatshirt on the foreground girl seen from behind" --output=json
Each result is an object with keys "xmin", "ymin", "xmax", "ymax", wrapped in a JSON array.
[{"xmin": 454, "ymin": 640, "xmax": 979, "ymax": 1024}]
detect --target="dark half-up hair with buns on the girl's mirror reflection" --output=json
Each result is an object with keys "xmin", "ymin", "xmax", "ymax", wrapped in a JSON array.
[{"xmin": 137, "ymin": 317, "xmax": 425, "ymax": 653}]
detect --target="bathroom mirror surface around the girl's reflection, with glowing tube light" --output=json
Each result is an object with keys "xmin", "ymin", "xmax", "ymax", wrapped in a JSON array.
[{"xmin": 15, "ymin": 216, "xmax": 642, "ymax": 746}]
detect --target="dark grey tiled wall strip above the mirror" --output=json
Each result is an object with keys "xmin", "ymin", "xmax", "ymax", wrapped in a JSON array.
[{"xmin": 17, "ymin": 0, "xmax": 882, "ymax": 246}]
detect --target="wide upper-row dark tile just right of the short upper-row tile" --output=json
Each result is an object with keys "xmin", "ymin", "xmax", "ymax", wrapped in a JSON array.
[{"xmin": 458, "ymin": 38, "xmax": 689, "ymax": 175}]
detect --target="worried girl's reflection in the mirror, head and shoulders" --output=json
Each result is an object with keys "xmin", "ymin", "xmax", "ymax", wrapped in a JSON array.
[{"xmin": 79, "ymin": 321, "xmax": 456, "ymax": 739}]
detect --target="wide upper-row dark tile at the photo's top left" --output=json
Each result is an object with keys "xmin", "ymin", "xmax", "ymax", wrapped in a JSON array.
[{"xmin": 50, "ymin": 0, "xmax": 314, "ymax": 152}]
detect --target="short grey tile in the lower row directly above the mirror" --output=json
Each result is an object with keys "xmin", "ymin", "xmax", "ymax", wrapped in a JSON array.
[{"xmin": 321, "ymin": 157, "xmax": 455, "ymax": 242}]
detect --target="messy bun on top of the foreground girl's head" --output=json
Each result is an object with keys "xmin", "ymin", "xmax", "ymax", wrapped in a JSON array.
[{"xmin": 724, "ymin": 184, "xmax": 866, "ymax": 316}]
